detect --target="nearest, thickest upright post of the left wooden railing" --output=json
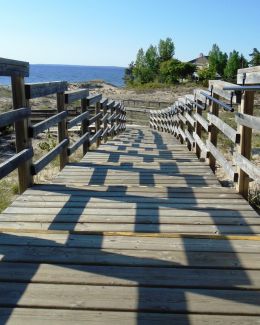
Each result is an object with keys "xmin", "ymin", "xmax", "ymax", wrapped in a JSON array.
[{"xmin": 11, "ymin": 75, "xmax": 33, "ymax": 193}]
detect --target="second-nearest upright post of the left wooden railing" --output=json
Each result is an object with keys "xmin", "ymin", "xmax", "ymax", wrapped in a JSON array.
[{"xmin": 57, "ymin": 92, "xmax": 69, "ymax": 170}]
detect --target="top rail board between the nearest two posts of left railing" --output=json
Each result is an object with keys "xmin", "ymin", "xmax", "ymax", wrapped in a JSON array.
[{"xmin": 25, "ymin": 81, "xmax": 68, "ymax": 99}]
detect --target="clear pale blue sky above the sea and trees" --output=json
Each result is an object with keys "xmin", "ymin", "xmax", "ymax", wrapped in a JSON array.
[{"xmin": 0, "ymin": 0, "xmax": 260, "ymax": 66}]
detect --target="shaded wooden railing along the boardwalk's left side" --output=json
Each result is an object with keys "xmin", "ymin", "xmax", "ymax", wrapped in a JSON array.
[{"xmin": 0, "ymin": 58, "xmax": 126, "ymax": 193}]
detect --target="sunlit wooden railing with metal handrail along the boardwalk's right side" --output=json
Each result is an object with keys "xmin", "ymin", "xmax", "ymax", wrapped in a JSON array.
[{"xmin": 150, "ymin": 67, "xmax": 260, "ymax": 198}]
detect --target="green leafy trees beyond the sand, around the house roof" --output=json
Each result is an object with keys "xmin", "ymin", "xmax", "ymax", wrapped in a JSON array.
[{"xmin": 125, "ymin": 38, "xmax": 260, "ymax": 86}]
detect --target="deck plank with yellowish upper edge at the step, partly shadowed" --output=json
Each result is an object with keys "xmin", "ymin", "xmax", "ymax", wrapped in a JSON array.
[{"xmin": 0, "ymin": 230, "xmax": 260, "ymax": 254}]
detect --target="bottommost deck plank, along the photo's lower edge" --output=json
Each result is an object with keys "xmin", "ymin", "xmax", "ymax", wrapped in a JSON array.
[{"xmin": 3, "ymin": 308, "xmax": 260, "ymax": 325}]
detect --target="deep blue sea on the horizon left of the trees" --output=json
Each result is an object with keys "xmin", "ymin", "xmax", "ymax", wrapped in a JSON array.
[{"xmin": 0, "ymin": 64, "xmax": 125, "ymax": 87}]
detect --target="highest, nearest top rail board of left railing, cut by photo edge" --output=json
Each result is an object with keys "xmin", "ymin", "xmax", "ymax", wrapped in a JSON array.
[{"xmin": 0, "ymin": 58, "xmax": 29, "ymax": 77}]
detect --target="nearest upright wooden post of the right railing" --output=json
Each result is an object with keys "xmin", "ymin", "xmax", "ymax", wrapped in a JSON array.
[{"xmin": 236, "ymin": 91, "xmax": 254, "ymax": 199}]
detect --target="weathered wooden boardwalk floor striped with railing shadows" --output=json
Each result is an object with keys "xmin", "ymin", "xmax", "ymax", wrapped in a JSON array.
[{"xmin": 0, "ymin": 127, "xmax": 260, "ymax": 325}]
